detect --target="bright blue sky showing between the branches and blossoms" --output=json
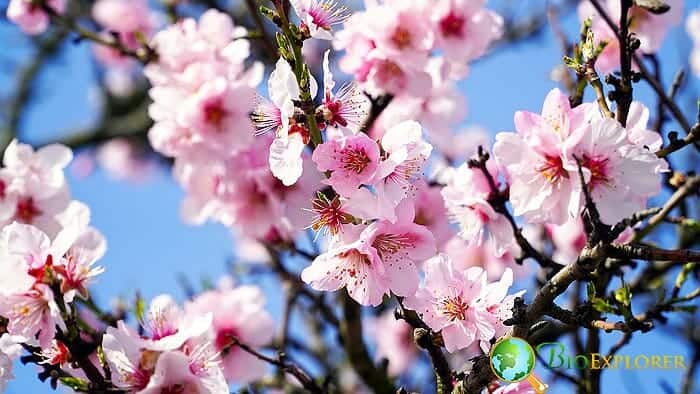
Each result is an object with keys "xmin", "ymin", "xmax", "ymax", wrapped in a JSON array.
[{"xmin": 0, "ymin": 0, "xmax": 700, "ymax": 394}]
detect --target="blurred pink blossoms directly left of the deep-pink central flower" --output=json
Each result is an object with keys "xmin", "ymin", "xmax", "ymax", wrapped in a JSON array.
[{"xmin": 174, "ymin": 137, "xmax": 320, "ymax": 240}]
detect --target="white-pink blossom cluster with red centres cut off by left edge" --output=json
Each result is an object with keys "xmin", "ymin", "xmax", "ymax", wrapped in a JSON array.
[{"xmin": 0, "ymin": 140, "xmax": 106, "ymax": 387}]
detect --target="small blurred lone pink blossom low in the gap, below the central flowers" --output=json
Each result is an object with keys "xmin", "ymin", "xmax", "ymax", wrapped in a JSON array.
[{"xmin": 368, "ymin": 311, "xmax": 418, "ymax": 376}]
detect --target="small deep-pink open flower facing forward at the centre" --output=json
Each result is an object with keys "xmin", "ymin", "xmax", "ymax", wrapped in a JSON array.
[{"xmin": 312, "ymin": 134, "xmax": 379, "ymax": 195}]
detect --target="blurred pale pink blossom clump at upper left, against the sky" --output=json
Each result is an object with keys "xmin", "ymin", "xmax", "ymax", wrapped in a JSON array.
[{"xmin": 144, "ymin": 10, "xmax": 262, "ymax": 157}]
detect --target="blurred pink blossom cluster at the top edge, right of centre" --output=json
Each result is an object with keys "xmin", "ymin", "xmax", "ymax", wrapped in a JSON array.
[{"xmin": 334, "ymin": 0, "xmax": 503, "ymax": 154}]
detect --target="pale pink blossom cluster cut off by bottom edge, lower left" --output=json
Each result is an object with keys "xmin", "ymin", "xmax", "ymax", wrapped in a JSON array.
[{"xmin": 102, "ymin": 281, "xmax": 274, "ymax": 394}]
